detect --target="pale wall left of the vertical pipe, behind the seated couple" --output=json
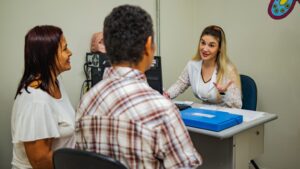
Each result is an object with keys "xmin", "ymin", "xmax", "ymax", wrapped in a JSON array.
[{"xmin": 0, "ymin": 0, "xmax": 155, "ymax": 169}]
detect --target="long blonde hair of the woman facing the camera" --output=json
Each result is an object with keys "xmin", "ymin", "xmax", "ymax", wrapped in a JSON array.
[{"xmin": 192, "ymin": 25, "xmax": 232, "ymax": 83}]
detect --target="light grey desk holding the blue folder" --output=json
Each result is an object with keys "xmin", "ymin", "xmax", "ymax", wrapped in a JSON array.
[{"xmin": 187, "ymin": 103, "xmax": 277, "ymax": 169}]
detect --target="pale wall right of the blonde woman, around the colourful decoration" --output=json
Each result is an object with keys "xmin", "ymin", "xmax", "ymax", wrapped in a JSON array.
[{"xmin": 188, "ymin": 0, "xmax": 300, "ymax": 169}]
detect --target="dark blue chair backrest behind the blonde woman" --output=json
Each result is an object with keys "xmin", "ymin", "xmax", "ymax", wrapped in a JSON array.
[{"xmin": 240, "ymin": 75, "xmax": 257, "ymax": 110}]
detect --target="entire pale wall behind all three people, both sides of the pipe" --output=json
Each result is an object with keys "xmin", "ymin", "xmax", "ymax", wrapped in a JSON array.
[{"xmin": 0, "ymin": 0, "xmax": 300, "ymax": 169}]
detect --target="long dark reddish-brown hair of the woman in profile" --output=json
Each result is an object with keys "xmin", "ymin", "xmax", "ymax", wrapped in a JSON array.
[{"xmin": 15, "ymin": 25, "xmax": 63, "ymax": 98}]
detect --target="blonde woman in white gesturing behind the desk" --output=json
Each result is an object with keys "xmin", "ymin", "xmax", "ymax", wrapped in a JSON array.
[{"xmin": 164, "ymin": 25, "xmax": 242, "ymax": 108}]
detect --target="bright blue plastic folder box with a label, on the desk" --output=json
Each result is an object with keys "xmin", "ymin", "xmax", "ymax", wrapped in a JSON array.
[{"xmin": 180, "ymin": 108, "xmax": 243, "ymax": 131}]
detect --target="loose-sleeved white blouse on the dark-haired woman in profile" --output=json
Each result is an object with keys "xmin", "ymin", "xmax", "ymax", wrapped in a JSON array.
[{"xmin": 11, "ymin": 80, "xmax": 75, "ymax": 169}]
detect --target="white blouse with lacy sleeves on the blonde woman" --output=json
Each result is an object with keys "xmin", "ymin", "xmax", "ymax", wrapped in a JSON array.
[{"xmin": 167, "ymin": 60, "xmax": 242, "ymax": 108}]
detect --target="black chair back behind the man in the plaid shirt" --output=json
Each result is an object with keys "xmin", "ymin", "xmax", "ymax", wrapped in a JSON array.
[{"xmin": 53, "ymin": 148, "xmax": 126, "ymax": 169}]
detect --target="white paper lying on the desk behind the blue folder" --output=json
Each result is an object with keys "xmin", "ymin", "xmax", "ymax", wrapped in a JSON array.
[{"xmin": 199, "ymin": 105, "xmax": 265, "ymax": 122}]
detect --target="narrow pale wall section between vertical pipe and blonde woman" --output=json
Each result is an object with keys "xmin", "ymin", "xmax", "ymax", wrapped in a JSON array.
[{"xmin": 160, "ymin": 0, "xmax": 198, "ymax": 101}]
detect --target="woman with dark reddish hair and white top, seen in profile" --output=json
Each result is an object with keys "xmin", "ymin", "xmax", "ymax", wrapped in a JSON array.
[{"xmin": 11, "ymin": 25, "xmax": 75, "ymax": 169}]
